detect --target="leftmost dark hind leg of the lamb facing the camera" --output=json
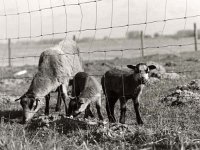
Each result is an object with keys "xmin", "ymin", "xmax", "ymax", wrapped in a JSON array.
[{"xmin": 106, "ymin": 97, "xmax": 117, "ymax": 123}]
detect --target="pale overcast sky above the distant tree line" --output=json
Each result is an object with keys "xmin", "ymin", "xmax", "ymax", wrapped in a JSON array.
[{"xmin": 0, "ymin": 0, "xmax": 200, "ymax": 39}]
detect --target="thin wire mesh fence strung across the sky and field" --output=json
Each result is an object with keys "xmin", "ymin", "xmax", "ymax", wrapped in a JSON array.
[{"xmin": 0, "ymin": 0, "xmax": 200, "ymax": 76}]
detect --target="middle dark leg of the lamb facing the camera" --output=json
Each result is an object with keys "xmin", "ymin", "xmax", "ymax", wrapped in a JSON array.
[{"xmin": 119, "ymin": 97, "xmax": 127, "ymax": 124}]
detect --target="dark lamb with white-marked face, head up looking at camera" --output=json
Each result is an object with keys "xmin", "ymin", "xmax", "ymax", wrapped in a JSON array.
[{"xmin": 101, "ymin": 63, "xmax": 156, "ymax": 124}]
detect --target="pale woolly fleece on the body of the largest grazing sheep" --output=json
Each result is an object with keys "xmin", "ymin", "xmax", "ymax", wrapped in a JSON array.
[{"xmin": 27, "ymin": 39, "xmax": 83, "ymax": 97}]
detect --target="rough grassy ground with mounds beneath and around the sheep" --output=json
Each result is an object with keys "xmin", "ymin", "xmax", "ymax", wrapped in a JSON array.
[{"xmin": 0, "ymin": 52, "xmax": 200, "ymax": 150}]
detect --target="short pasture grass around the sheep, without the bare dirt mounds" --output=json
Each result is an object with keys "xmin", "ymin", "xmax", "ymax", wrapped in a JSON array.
[{"xmin": 0, "ymin": 52, "xmax": 200, "ymax": 150}]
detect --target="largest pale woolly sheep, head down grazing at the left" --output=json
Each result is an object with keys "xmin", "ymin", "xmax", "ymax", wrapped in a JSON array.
[{"xmin": 16, "ymin": 39, "xmax": 82, "ymax": 123}]
